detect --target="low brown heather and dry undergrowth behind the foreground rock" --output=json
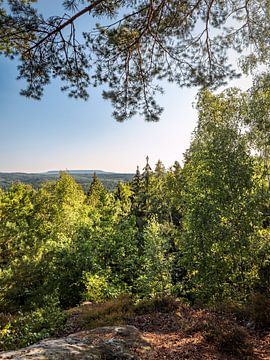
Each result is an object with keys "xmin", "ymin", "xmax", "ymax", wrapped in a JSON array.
[{"xmin": 66, "ymin": 296, "xmax": 253, "ymax": 359}]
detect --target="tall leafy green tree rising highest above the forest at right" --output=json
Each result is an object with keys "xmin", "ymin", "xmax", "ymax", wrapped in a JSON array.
[{"xmin": 180, "ymin": 91, "xmax": 266, "ymax": 302}]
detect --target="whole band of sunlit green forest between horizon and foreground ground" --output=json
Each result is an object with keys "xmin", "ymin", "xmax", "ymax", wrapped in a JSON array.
[{"xmin": 0, "ymin": 83, "xmax": 270, "ymax": 349}]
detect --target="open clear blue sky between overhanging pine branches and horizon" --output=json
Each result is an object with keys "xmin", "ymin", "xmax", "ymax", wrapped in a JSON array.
[{"xmin": 0, "ymin": 0, "xmax": 252, "ymax": 172}]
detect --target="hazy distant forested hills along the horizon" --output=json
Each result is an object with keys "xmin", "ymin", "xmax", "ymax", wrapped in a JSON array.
[{"xmin": 0, "ymin": 170, "xmax": 134, "ymax": 191}]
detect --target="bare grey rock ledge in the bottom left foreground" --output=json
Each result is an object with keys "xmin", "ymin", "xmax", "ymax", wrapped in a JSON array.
[{"xmin": 0, "ymin": 326, "xmax": 150, "ymax": 360}]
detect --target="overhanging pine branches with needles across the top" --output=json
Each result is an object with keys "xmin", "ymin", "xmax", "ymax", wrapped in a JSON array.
[{"xmin": 0, "ymin": 0, "xmax": 270, "ymax": 121}]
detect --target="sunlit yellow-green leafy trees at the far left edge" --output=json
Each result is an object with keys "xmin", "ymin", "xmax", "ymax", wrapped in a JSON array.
[{"xmin": 0, "ymin": 174, "xmax": 84, "ymax": 311}]
